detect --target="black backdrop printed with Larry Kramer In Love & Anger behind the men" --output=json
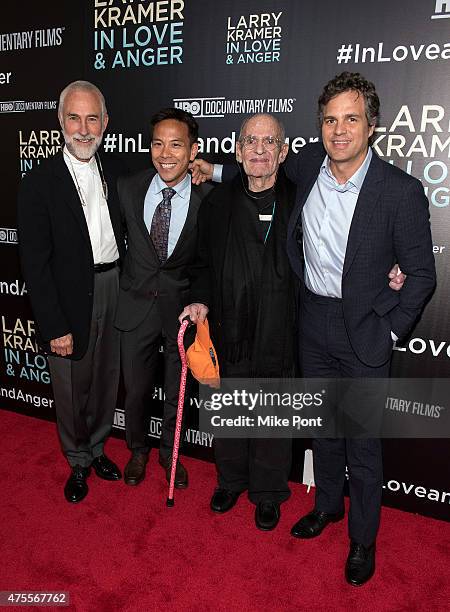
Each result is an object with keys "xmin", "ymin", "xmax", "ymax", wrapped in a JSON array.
[{"xmin": 0, "ymin": 0, "xmax": 450, "ymax": 520}]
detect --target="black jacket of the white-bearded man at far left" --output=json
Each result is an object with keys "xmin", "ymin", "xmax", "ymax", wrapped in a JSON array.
[{"xmin": 18, "ymin": 152, "xmax": 125, "ymax": 359}]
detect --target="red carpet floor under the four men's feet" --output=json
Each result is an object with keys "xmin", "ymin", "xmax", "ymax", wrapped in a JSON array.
[{"xmin": 0, "ymin": 411, "xmax": 450, "ymax": 612}]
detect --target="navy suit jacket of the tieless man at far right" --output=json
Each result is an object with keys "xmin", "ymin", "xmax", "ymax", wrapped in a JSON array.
[{"xmin": 286, "ymin": 143, "xmax": 436, "ymax": 367}]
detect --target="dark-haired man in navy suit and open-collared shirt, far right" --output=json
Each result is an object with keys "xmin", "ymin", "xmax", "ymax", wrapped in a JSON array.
[{"xmin": 288, "ymin": 72, "xmax": 435, "ymax": 586}]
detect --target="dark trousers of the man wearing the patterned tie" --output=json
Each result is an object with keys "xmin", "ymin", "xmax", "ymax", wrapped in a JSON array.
[{"xmin": 121, "ymin": 304, "xmax": 181, "ymax": 459}]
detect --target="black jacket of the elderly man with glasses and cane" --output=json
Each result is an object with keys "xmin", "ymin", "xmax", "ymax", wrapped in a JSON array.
[{"xmin": 191, "ymin": 169, "xmax": 297, "ymax": 377}]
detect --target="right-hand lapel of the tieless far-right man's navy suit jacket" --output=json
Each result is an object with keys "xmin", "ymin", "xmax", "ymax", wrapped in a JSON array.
[{"xmin": 342, "ymin": 153, "xmax": 383, "ymax": 277}]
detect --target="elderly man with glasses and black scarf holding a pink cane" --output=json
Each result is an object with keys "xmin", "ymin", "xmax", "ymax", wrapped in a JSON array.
[{"xmin": 180, "ymin": 114, "xmax": 295, "ymax": 530}]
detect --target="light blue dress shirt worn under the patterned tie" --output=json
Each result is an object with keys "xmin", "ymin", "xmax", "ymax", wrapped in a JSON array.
[{"xmin": 144, "ymin": 174, "xmax": 191, "ymax": 257}]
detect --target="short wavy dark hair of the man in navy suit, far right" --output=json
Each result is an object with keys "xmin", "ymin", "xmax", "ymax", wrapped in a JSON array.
[{"xmin": 318, "ymin": 72, "xmax": 380, "ymax": 125}]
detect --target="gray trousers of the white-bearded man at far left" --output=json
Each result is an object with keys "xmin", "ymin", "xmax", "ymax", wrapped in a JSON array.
[{"xmin": 48, "ymin": 267, "xmax": 120, "ymax": 467}]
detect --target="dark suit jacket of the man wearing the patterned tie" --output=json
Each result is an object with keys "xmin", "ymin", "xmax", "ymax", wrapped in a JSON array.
[{"xmin": 112, "ymin": 169, "xmax": 211, "ymax": 336}]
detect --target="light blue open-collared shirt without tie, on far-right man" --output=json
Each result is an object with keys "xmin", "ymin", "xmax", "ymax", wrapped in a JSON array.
[{"xmin": 302, "ymin": 147, "xmax": 372, "ymax": 298}]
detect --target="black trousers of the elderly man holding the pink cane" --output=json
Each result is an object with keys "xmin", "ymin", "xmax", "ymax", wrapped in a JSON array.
[{"xmin": 214, "ymin": 355, "xmax": 292, "ymax": 504}]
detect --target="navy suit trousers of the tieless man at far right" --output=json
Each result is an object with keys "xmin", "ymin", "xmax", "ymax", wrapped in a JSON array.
[{"xmin": 300, "ymin": 290, "xmax": 390, "ymax": 546}]
